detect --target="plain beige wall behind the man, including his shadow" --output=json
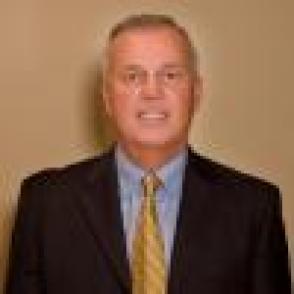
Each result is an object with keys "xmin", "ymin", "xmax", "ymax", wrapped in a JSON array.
[{"xmin": 0, "ymin": 0, "xmax": 294, "ymax": 293}]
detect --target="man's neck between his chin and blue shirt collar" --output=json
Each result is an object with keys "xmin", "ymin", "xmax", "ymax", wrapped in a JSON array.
[{"xmin": 119, "ymin": 142, "xmax": 187, "ymax": 170}]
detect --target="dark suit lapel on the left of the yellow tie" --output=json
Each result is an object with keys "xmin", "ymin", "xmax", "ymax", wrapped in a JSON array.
[{"xmin": 70, "ymin": 151, "xmax": 130, "ymax": 289}]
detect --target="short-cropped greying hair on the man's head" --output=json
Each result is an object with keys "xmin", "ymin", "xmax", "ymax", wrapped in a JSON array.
[{"xmin": 106, "ymin": 14, "xmax": 199, "ymax": 75}]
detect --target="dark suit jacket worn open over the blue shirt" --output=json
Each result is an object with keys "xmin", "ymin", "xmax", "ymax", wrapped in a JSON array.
[{"xmin": 6, "ymin": 150, "xmax": 291, "ymax": 294}]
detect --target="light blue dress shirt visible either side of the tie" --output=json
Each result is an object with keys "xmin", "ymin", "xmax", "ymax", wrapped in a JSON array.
[{"xmin": 115, "ymin": 146, "xmax": 186, "ymax": 269}]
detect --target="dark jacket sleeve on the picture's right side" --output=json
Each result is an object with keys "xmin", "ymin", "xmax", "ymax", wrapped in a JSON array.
[{"xmin": 252, "ymin": 187, "xmax": 291, "ymax": 294}]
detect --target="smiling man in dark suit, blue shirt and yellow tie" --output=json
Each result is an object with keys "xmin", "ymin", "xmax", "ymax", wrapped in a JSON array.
[{"xmin": 7, "ymin": 15, "xmax": 291, "ymax": 294}]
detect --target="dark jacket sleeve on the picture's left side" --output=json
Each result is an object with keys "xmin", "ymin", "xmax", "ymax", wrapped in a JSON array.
[{"xmin": 5, "ymin": 175, "xmax": 47, "ymax": 294}]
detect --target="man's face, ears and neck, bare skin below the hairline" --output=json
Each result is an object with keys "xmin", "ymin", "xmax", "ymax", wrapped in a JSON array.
[{"xmin": 103, "ymin": 26, "xmax": 201, "ymax": 169}]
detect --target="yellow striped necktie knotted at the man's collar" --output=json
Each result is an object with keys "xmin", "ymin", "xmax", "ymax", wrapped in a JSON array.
[{"xmin": 131, "ymin": 172, "xmax": 167, "ymax": 294}]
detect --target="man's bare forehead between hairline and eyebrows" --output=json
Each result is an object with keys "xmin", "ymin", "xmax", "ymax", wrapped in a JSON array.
[{"xmin": 108, "ymin": 26, "xmax": 188, "ymax": 65}]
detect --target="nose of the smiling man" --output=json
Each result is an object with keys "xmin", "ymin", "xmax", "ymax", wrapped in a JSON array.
[{"xmin": 141, "ymin": 73, "xmax": 162, "ymax": 100}]
